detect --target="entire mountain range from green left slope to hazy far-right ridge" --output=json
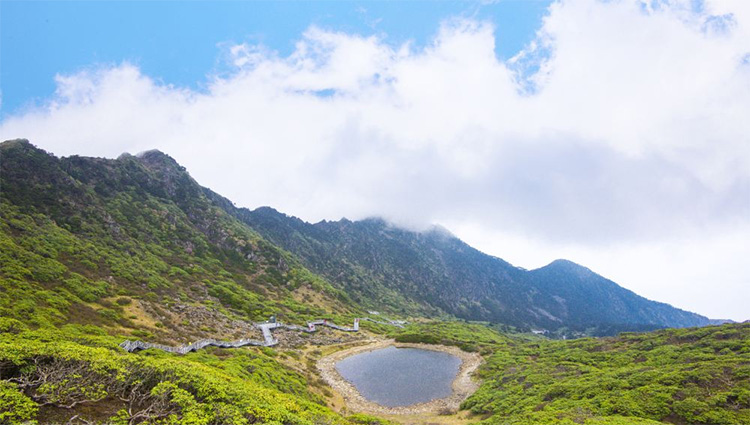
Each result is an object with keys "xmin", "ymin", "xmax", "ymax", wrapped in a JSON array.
[{"xmin": 0, "ymin": 140, "xmax": 709, "ymax": 339}]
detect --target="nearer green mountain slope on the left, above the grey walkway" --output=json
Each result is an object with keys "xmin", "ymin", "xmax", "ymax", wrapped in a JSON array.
[{"xmin": 0, "ymin": 141, "xmax": 356, "ymax": 343}]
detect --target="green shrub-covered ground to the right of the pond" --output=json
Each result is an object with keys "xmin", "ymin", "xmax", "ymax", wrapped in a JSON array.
[{"xmin": 463, "ymin": 324, "xmax": 750, "ymax": 424}]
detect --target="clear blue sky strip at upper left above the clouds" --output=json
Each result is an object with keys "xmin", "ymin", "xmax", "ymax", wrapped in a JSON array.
[{"xmin": 0, "ymin": 0, "xmax": 550, "ymax": 116}]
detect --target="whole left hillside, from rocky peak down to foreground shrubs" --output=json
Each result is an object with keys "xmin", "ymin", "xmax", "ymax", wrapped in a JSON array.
[{"xmin": 0, "ymin": 141, "xmax": 394, "ymax": 424}]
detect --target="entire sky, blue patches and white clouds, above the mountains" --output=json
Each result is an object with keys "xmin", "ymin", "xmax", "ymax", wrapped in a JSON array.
[{"xmin": 0, "ymin": 0, "xmax": 750, "ymax": 320}]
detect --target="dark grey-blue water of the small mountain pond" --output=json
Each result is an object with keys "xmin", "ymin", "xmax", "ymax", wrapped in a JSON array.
[{"xmin": 336, "ymin": 347, "xmax": 461, "ymax": 407}]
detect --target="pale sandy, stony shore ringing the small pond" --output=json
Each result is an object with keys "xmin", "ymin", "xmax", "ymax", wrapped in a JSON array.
[{"xmin": 318, "ymin": 340, "xmax": 482, "ymax": 415}]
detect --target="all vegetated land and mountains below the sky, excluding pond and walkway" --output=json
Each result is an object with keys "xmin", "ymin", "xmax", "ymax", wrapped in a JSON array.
[{"xmin": 0, "ymin": 141, "xmax": 750, "ymax": 425}]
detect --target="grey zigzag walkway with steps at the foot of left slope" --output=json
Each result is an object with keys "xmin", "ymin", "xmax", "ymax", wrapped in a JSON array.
[{"xmin": 120, "ymin": 317, "xmax": 406, "ymax": 354}]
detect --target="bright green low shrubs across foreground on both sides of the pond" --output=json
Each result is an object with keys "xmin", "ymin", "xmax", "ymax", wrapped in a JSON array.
[{"xmin": 5, "ymin": 319, "xmax": 750, "ymax": 425}]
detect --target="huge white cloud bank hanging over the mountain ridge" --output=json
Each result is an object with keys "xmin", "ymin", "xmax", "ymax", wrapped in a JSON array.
[{"xmin": 0, "ymin": 0, "xmax": 750, "ymax": 319}]
